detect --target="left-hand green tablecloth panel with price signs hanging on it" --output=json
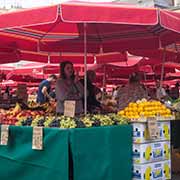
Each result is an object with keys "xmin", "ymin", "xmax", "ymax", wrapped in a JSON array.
[{"xmin": 0, "ymin": 126, "xmax": 69, "ymax": 180}]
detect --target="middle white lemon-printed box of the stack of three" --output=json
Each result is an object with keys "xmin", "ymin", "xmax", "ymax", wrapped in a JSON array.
[{"xmin": 133, "ymin": 141, "xmax": 171, "ymax": 164}]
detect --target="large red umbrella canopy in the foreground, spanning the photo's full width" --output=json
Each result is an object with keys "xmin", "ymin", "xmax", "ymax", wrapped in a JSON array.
[{"xmin": 0, "ymin": 2, "xmax": 180, "ymax": 53}]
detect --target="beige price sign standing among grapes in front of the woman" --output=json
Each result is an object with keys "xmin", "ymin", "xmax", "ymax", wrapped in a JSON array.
[{"xmin": 64, "ymin": 101, "xmax": 76, "ymax": 117}]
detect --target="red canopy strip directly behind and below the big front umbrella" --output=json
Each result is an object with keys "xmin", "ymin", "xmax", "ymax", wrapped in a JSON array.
[{"xmin": 0, "ymin": 48, "xmax": 127, "ymax": 64}]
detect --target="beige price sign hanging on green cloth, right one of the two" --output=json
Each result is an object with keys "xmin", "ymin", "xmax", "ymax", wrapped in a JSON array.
[{"xmin": 32, "ymin": 127, "xmax": 43, "ymax": 150}]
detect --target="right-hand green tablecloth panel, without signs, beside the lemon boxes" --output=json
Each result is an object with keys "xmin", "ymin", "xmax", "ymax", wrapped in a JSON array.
[{"xmin": 70, "ymin": 125, "xmax": 132, "ymax": 180}]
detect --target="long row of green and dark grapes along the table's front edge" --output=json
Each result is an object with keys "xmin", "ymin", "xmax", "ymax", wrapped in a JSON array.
[{"xmin": 16, "ymin": 111, "xmax": 128, "ymax": 129}]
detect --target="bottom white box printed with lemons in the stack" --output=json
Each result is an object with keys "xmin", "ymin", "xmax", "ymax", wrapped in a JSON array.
[{"xmin": 132, "ymin": 161, "xmax": 171, "ymax": 180}]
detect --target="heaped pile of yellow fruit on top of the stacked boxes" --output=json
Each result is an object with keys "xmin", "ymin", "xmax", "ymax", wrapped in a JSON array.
[{"xmin": 118, "ymin": 99, "xmax": 172, "ymax": 119}]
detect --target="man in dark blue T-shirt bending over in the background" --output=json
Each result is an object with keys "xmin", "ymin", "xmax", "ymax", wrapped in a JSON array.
[{"xmin": 37, "ymin": 74, "xmax": 57, "ymax": 104}]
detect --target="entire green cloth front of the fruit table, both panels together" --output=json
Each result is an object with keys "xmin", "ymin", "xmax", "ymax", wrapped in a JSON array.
[{"xmin": 0, "ymin": 125, "xmax": 132, "ymax": 180}]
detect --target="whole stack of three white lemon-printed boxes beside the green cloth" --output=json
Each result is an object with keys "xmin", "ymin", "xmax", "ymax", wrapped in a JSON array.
[{"xmin": 132, "ymin": 121, "xmax": 171, "ymax": 180}]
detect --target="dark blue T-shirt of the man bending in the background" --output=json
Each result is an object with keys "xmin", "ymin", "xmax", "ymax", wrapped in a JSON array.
[{"xmin": 37, "ymin": 80, "xmax": 51, "ymax": 104}]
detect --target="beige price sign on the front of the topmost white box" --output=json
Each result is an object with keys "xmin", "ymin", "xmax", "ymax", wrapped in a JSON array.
[{"xmin": 147, "ymin": 118, "xmax": 159, "ymax": 139}]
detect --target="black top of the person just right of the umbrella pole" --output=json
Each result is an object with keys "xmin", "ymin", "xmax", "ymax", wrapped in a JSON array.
[{"xmin": 80, "ymin": 79, "xmax": 101, "ymax": 112}]
